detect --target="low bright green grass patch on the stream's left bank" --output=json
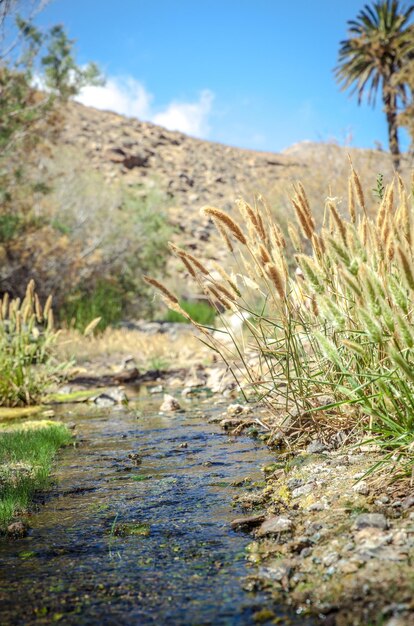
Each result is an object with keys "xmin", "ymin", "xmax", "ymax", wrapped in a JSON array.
[{"xmin": 0, "ymin": 422, "xmax": 72, "ymax": 530}]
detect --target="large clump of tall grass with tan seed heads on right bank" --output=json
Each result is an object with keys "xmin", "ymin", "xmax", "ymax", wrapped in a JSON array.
[{"xmin": 154, "ymin": 168, "xmax": 414, "ymax": 473}]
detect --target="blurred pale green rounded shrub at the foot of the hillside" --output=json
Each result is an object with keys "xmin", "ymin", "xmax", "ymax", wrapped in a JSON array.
[{"xmin": 51, "ymin": 168, "xmax": 171, "ymax": 330}]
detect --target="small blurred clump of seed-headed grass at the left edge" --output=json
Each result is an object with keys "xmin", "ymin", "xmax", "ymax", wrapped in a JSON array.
[{"xmin": 0, "ymin": 281, "xmax": 64, "ymax": 406}]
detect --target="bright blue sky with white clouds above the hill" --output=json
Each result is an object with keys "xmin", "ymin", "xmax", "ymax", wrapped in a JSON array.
[{"xmin": 37, "ymin": 0, "xmax": 408, "ymax": 151}]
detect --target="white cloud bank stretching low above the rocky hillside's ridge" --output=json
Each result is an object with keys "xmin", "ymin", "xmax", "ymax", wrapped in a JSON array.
[{"xmin": 76, "ymin": 77, "xmax": 214, "ymax": 138}]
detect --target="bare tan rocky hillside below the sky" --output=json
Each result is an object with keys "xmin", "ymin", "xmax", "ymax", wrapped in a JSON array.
[{"xmin": 57, "ymin": 103, "xmax": 410, "ymax": 256}]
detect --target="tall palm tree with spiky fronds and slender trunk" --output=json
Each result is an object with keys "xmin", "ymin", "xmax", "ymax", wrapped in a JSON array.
[{"xmin": 335, "ymin": 0, "xmax": 414, "ymax": 169}]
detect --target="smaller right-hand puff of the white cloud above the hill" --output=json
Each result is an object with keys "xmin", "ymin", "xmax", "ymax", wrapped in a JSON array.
[{"xmin": 152, "ymin": 89, "xmax": 214, "ymax": 137}]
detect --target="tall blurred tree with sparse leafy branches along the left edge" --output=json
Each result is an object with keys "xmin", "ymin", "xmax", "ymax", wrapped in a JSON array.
[{"xmin": 0, "ymin": 11, "xmax": 108, "ymax": 308}]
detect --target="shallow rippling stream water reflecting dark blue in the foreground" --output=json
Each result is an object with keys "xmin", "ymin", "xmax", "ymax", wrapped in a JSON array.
[{"xmin": 0, "ymin": 392, "xmax": 309, "ymax": 626}]
